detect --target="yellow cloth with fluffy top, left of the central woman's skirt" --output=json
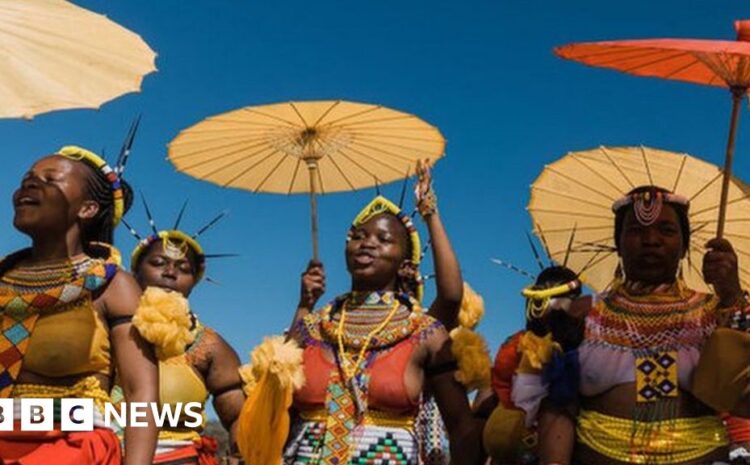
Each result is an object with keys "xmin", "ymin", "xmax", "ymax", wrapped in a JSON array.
[{"xmin": 237, "ymin": 336, "xmax": 305, "ymax": 465}]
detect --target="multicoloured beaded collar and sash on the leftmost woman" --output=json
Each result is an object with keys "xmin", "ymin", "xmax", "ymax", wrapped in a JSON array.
[{"xmin": 0, "ymin": 251, "xmax": 117, "ymax": 397}]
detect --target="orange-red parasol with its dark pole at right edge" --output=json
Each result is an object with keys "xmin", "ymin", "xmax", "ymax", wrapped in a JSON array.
[{"xmin": 555, "ymin": 20, "xmax": 750, "ymax": 237}]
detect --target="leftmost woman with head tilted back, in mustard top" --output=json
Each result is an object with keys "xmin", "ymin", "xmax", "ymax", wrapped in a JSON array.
[{"xmin": 0, "ymin": 147, "xmax": 157, "ymax": 465}]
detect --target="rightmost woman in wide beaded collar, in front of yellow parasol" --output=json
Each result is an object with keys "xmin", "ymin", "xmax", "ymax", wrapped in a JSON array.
[{"xmin": 539, "ymin": 186, "xmax": 748, "ymax": 465}]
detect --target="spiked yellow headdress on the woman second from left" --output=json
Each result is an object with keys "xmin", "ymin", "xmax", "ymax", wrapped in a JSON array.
[{"xmin": 123, "ymin": 198, "xmax": 230, "ymax": 281}]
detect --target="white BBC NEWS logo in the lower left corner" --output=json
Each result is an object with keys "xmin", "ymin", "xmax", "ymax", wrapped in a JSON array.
[{"xmin": 0, "ymin": 398, "xmax": 203, "ymax": 431}]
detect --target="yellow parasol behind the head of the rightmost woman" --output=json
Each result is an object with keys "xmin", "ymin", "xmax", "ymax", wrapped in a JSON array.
[{"xmin": 528, "ymin": 147, "xmax": 750, "ymax": 291}]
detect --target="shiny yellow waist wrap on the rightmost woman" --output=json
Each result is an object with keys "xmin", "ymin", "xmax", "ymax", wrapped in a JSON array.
[{"xmin": 576, "ymin": 410, "xmax": 729, "ymax": 465}]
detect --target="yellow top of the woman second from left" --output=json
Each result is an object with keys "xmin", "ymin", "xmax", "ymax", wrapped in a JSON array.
[{"xmin": 159, "ymin": 354, "xmax": 209, "ymax": 440}]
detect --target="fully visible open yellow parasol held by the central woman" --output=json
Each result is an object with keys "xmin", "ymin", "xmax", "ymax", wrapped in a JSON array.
[{"xmin": 169, "ymin": 100, "xmax": 445, "ymax": 259}]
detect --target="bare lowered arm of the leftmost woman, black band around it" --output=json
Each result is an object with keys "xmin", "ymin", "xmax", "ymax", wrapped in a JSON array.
[{"xmin": 101, "ymin": 271, "xmax": 159, "ymax": 465}]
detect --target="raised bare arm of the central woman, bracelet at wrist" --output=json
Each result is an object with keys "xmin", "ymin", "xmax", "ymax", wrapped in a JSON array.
[{"xmin": 415, "ymin": 162, "xmax": 463, "ymax": 331}]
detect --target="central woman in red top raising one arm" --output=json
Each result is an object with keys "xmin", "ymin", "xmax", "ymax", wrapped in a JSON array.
[{"xmin": 239, "ymin": 160, "xmax": 488, "ymax": 465}]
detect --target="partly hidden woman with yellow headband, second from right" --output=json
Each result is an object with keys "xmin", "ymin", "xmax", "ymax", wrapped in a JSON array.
[{"xmin": 482, "ymin": 265, "xmax": 582, "ymax": 465}]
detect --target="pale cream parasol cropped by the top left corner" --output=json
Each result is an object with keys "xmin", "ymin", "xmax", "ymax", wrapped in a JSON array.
[{"xmin": 0, "ymin": 0, "xmax": 156, "ymax": 118}]
